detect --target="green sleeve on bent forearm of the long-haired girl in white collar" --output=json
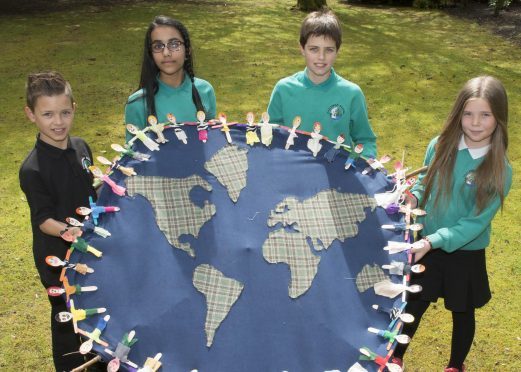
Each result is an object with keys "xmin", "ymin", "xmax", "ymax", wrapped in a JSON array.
[{"xmin": 427, "ymin": 167, "xmax": 512, "ymax": 253}]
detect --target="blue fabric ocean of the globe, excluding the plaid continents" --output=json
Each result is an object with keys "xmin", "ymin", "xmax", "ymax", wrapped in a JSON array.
[{"xmin": 68, "ymin": 127, "xmax": 405, "ymax": 372}]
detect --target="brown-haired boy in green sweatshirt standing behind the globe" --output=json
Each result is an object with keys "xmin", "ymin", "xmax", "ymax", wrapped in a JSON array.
[{"xmin": 268, "ymin": 10, "xmax": 376, "ymax": 157}]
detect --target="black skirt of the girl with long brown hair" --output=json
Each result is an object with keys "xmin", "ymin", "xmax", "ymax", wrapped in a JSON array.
[{"xmin": 411, "ymin": 249, "xmax": 492, "ymax": 312}]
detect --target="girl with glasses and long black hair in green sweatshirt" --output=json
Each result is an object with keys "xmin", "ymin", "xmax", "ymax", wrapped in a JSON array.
[{"xmin": 125, "ymin": 16, "xmax": 216, "ymax": 141}]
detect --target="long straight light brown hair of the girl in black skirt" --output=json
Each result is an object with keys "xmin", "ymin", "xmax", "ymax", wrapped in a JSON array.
[{"xmin": 422, "ymin": 76, "xmax": 508, "ymax": 213}]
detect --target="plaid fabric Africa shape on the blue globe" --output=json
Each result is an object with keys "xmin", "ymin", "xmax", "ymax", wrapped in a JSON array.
[{"xmin": 262, "ymin": 229, "xmax": 320, "ymax": 298}]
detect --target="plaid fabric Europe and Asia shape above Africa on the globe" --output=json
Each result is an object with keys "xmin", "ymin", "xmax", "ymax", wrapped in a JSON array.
[{"xmin": 268, "ymin": 189, "xmax": 376, "ymax": 250}]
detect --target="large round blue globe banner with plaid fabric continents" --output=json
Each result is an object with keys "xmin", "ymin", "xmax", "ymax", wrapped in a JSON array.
[{"xmin": 66, "ymin": 120, "xmax": 407, "ymax": 372}]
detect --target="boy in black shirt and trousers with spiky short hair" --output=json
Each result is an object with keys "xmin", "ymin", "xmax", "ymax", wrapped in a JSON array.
[{"xmin": 19, "ymin": 72, "xmax": 96, "ymax": 371}]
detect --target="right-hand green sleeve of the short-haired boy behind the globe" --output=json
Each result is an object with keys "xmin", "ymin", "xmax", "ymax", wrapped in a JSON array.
[{"xmin": 349, "ymin": 91, "xmax": 376, "ymax": 158}]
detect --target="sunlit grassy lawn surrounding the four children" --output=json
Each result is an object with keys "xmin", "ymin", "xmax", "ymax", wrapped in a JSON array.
[{"xmin": 0, "ymin": 0, "xmax": 521, "ymax": 371}]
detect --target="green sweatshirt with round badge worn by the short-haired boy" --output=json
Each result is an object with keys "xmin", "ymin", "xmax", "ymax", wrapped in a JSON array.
[{"xmin": 268, "ymin": 69, "xmax": 376, "ymax": 157}]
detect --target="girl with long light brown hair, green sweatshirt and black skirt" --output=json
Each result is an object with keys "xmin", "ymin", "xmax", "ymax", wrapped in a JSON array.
[{"xmin": 393, "ymin": 76, "xmax": 512, "ymax": 372}]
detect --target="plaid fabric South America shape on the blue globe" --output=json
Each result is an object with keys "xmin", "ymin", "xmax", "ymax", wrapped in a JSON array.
[{"xmin": 193, "ymin": 264, "xmax": 244, "ymax": 347}]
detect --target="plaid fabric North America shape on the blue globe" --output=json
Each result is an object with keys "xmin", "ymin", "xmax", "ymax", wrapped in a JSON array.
[{"xmin": 127, "ymin": 175, "xmax": 215, "ymax": 257}]
